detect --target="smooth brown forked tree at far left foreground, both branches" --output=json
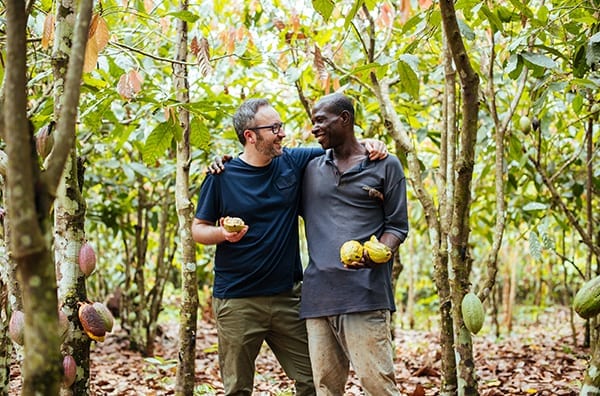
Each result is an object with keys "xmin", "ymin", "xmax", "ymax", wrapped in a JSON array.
[{"xmin": 2, "ymin": 1, "xmax": 92, "ymax": 395}]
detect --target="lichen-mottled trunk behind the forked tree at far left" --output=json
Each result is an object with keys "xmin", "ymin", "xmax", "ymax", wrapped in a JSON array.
[{"xmin": 52, "ymin": 1, "xmax": 91, "ymax": 395}]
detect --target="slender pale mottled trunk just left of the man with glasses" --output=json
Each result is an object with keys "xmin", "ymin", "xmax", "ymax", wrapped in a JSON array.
[{"xmin": 173, "ymin": 0, "xmax": 198, "ymax": 395}]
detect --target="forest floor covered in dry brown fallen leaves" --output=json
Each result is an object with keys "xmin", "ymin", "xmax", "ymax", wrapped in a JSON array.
[{"xmin": 10, "ymin": 308, "xmax": 589, "ymax": 396}]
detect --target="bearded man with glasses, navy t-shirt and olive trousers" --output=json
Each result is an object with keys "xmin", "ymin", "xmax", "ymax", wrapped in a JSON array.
[{"xmin": 192, "ymin": 99, "xmax": 387, "ymax": 396}]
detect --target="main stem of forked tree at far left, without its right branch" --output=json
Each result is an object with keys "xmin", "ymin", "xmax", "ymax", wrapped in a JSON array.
[{"xmin": 3, "ymin": 0, "xmax": 61, "ymax": 395}]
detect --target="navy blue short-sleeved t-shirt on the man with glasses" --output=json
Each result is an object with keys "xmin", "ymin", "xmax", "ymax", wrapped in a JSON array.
[{"xmin": 196, "ymin": 148, "xmax": 324, "ymax": 298}]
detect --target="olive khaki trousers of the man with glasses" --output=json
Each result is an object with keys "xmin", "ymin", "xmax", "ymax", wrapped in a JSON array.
[{"xmin": 213, "ymin": 283, "xmax": 315, "ymax": 396}]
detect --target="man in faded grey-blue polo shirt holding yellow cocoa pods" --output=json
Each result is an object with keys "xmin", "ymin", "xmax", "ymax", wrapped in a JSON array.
[{"xmin": 300, "ymin": 94, "xmax": 408, "ymax": 396}]
